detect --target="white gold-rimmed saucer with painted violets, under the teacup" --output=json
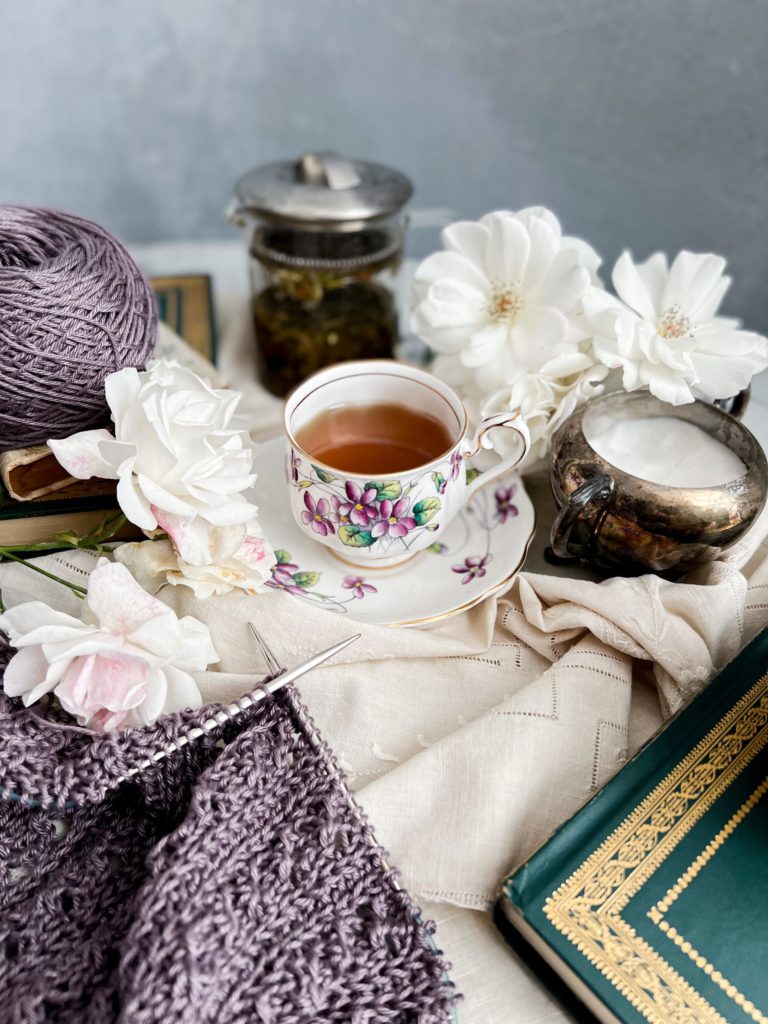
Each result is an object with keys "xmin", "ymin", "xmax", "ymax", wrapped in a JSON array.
[{"xmin": 249, "ymin": 437, "xmax": 536, "ymax": 626}]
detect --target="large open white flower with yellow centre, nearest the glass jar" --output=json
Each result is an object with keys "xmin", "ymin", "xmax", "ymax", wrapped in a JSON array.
[{"xmin": 412, "ymin": 207, "xmax": 600, "ymax": 393}]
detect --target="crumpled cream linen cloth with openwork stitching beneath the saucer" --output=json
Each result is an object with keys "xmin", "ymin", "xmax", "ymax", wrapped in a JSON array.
[{"xmin": 0, "ymin": 519, "xmax": 768, "ymax": 1024}]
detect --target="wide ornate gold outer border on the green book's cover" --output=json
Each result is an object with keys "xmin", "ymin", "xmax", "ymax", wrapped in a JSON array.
[{"xmin": 544, "ymin": 675, "xmax": 768, "ymax": 1024}]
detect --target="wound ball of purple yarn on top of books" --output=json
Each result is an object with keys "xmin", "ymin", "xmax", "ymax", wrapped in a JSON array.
[{"xmin": 0, "ymin": 206, "xmax": 157, "ymax": 451}]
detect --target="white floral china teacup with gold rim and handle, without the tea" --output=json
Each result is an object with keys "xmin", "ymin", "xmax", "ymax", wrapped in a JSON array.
[{"xmin": 285, "ymin": 359, "xmax": 530, "ymax": 567}]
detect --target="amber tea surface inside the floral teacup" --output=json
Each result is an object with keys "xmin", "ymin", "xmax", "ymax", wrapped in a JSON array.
[{"xmin": 296, "ymin": 401, "xmax": 456, "ymax": 476}]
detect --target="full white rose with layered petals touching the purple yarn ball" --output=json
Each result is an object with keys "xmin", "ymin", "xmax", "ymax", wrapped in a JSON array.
[{"xmin": 48, "ymin": 359, "xmax": 256, "ymax": 536}]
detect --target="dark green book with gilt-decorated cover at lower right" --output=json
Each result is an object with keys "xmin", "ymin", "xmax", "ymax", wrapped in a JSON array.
[{"xmin": 496, "ymin": 630, "xmax": 768, "ymax": 1024}]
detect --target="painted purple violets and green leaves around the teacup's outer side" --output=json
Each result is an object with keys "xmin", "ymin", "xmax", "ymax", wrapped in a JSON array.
[{"xmin": 288, "ymin": 449, "xmax": 463, "ymax": 557}]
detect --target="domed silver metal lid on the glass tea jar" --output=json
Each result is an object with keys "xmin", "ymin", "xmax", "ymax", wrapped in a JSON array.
[{"xmin": 234, "ymin": 153, "xmax": 414, "ymax": 229}]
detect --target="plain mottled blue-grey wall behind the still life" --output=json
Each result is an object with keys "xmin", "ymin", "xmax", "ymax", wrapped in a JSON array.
[{"xmin": 0, "ymin": 0, "xmax": 768, "ymax": 331}]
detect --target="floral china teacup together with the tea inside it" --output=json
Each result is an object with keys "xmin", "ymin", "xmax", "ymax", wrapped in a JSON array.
[{"xmin": 285, "ymin": 359, "xmax": 530, "ymax": 568}]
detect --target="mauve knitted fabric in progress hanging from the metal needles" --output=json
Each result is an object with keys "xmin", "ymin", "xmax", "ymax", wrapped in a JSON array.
[{"xmin": 0, "ymin": 647, "xmax": 455, "ymax": 1024}]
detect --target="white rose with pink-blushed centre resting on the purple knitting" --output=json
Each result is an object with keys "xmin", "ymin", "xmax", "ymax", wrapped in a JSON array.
[{"xmin": 0, "ymin": 558, "xmax": 218, "ymax": 732}]
